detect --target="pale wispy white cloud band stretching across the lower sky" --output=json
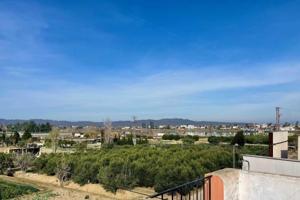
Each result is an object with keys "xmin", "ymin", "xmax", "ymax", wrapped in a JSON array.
[{"xmin": 1, "ymin": 60, "xmax": 300, "ymax": 120}]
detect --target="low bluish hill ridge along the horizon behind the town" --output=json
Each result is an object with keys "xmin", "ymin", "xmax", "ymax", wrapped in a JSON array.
[{"xmin": 0, "ymin": 118, "xmax": 245, "ymax": 127}]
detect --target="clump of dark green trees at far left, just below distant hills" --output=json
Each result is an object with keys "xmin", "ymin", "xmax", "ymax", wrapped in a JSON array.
[{"xmin": 7, "ymin": 121, "xmax": 52, "ymax": 133}]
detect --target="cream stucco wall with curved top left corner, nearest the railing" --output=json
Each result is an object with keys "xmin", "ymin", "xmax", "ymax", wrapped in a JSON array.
[{"xmin": 209, "ymin": 169, "xmax": 300, "ymax": 200}]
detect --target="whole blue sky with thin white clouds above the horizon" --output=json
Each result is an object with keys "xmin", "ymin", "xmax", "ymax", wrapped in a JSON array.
[{"xmin": 0, "ymin": 0, "xmax": 300, "ymax": 122}]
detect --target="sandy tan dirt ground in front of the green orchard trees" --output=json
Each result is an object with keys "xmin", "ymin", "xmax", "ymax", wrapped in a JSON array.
[{"xmin": 0, "ymin": 172, "xmax": 154, "ymax": 200}]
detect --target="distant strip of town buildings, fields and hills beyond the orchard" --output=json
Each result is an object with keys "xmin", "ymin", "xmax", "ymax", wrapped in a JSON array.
[{"xmin": 0, "ymin": 119, "xmax": 299, "ymax": 152}]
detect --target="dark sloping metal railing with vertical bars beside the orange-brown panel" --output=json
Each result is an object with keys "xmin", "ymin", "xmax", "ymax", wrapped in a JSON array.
[{"xmin": 149, "ymin": 176, "xmax": 211, "ymax": 200}]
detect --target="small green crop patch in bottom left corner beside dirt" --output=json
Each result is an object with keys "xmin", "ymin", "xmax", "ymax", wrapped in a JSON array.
[{"xmin": 0, "ymin": 179, "xmax": 39, "ymax": 200}]
